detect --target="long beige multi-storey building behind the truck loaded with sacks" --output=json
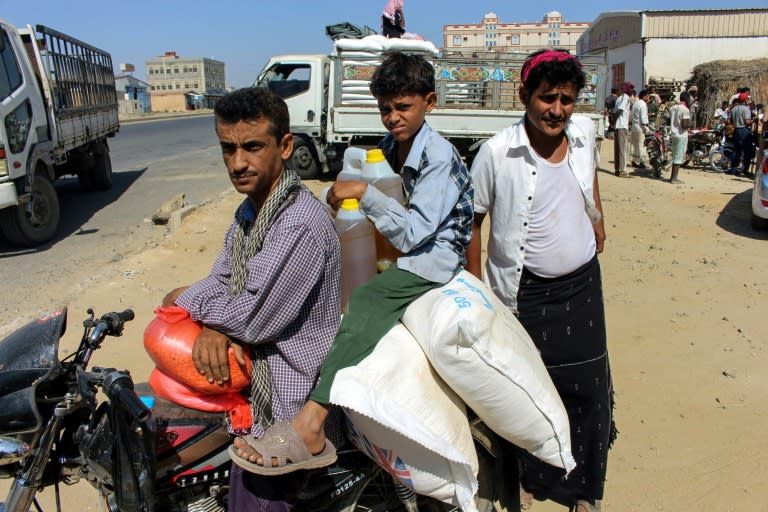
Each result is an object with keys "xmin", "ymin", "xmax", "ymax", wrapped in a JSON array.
[{"xmin": 443, "ymin": 11, "xmax": 590, "ymax": 55}]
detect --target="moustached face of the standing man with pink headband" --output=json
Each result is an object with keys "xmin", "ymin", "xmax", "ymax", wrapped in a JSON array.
[{"xmin": 520, "ymin": 80, "xmax": 579, "ymax": 137}]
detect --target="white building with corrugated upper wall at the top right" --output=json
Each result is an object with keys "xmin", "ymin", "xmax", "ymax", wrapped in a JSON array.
[{"xmin": 576, "ymin": 8, "xmax": 768, "ymax": 97}]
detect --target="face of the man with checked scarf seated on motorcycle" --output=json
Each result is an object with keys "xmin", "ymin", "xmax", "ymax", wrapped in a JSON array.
[{"xmin": 216, "ymin": 117, "xmax": 293, "ymax": 207}]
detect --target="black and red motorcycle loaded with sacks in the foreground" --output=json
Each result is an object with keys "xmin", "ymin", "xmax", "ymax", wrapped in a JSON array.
[{"xmin": 0, "ymin": 308, "xmax": 519, "ymax": 512}]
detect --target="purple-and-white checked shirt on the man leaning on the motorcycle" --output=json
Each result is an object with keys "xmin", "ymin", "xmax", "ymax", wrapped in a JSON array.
[{"xmin": 176, "ymin": 190, "xmax": 342, "ymax": 446}]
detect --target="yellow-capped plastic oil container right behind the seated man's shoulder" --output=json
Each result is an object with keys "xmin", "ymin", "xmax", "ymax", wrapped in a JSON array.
[{"xmin": 335, "ymin": 199, "xmax": 376, "ymax": 313}]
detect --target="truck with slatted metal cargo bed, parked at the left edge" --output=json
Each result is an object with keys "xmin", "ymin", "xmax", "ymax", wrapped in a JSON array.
[{"xmin": 0, "ymin": 19, "xmax": 120, "ymax": 247}]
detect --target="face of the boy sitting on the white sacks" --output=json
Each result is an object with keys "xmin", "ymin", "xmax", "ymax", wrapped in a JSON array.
[{"xmin": 378, "ymin": 92, "xmax": 437, "ymax": 142}]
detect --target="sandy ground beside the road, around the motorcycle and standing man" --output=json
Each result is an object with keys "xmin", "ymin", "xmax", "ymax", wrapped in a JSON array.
[{"xmin": 2, "ymin": 141, "xmax": 768, "ymax": 512}]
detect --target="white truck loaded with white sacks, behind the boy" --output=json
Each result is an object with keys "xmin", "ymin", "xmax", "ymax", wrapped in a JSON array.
[{"xmin": 254, "ymin": 36, "xmax": 606, "ymax": 179}]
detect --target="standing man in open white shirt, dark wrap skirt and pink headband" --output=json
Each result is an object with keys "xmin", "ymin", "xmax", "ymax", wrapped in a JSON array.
[{"xmin": 467, "ymin": 50, "xmax": 616, "ymax": 512}]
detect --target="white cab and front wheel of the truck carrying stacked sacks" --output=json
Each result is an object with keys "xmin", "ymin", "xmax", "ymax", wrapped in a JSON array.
[{"xmin": 254, "ymin": 55, "xmax": 330, "ymax": 178}]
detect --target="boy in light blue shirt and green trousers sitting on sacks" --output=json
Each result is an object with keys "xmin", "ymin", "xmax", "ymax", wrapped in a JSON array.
[{"xmin": 230, "ymin": 52, "xmax": 473, "ymax": 475}]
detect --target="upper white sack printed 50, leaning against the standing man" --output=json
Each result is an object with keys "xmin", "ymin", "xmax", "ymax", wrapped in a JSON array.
[{"xmin": 403, "ymin": 270, "xmax": 576, "ymax": 472}]
